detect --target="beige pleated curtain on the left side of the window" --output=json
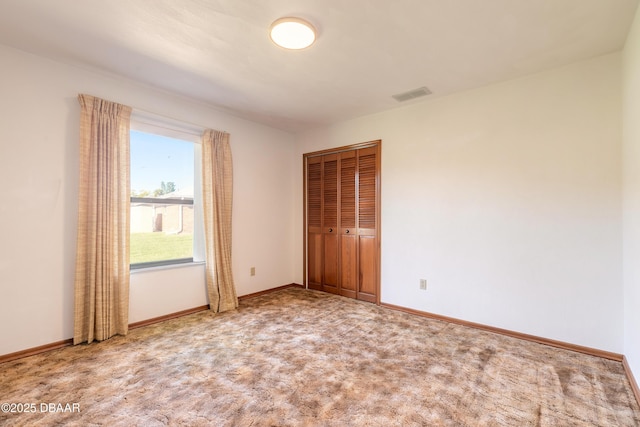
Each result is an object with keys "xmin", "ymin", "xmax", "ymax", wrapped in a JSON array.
[{"xmin": 73, "ymin": 95, "xmax": 131, "ymax": 344}]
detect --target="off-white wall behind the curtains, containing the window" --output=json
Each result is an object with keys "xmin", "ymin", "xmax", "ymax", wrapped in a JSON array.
[{"xmin": 0, "ymin": 45, "xmax": 297, "ymax": 355}]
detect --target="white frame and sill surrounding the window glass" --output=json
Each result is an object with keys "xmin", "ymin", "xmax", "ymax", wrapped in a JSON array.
[{"xmin": 130, "ymin": 109, "xmax": 205, "ymax": 273}]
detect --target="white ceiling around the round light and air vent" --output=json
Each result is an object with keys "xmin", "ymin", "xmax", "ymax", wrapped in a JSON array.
[{"xmin": 0, "ymin": 0, "xmax": 639, "ymax": 132}]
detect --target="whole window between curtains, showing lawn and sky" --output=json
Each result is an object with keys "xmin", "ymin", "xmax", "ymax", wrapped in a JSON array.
[{"xmin": 129, "ymin": 116, "xmax": 204, "ymax": 270}]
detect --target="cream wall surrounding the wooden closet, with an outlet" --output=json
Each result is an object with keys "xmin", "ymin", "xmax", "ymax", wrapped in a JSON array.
[{"xmin": 295, "ymin": 54, "xmax": 623, "ymax": 352}]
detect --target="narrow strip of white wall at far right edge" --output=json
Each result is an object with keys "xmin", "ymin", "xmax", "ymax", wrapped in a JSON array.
[{"xmin": 623, "ymin": 3, "xmax": 640, "ymax": 381}]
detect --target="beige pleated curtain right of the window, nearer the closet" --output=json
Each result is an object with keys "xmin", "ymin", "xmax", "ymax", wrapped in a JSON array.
[{"xmin": 202, "ymin": 129, "xmax": 238, "ymax": 312}]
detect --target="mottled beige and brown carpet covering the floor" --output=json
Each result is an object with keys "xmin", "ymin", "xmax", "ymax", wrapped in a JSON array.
[{"xmin": 0, "ymin": 288, "xmax": 640, "ymax": 426}]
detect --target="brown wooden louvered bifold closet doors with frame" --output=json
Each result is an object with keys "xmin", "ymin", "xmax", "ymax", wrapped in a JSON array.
[{"xmin": 304, "ymin": 141, "xmax": 380, "ymax": 303}]
